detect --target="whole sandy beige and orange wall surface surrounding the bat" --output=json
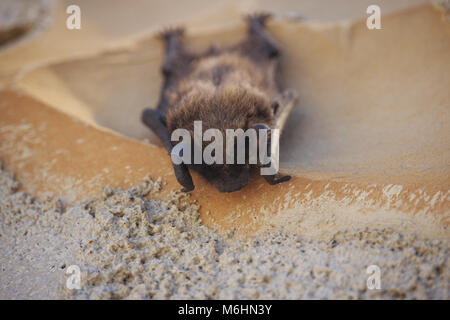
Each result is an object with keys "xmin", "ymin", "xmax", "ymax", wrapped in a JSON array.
[{"xmin": 0, "ymin": 0, "xmax": 450, "ymax": 299}]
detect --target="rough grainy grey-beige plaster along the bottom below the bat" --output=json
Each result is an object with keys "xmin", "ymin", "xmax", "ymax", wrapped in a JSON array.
[{"xmin": 0, "ymin": 165, "xmax": 450, "ymax": 299}]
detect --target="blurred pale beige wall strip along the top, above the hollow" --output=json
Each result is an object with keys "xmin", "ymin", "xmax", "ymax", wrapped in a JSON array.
[{"xmin": 0, "ymin": 0, "xmax": 425, "ymax": 87}]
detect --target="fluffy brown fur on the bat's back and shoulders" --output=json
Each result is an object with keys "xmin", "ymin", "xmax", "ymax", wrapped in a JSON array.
[{"xmin": 166, "ymin": 52, "xmax": 278, "ymax": 133}]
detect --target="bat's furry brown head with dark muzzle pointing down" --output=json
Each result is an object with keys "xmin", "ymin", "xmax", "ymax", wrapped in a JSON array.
[{"xmin": 166, "ymin": 87, "xmax": 273, "ymax": 192}]
